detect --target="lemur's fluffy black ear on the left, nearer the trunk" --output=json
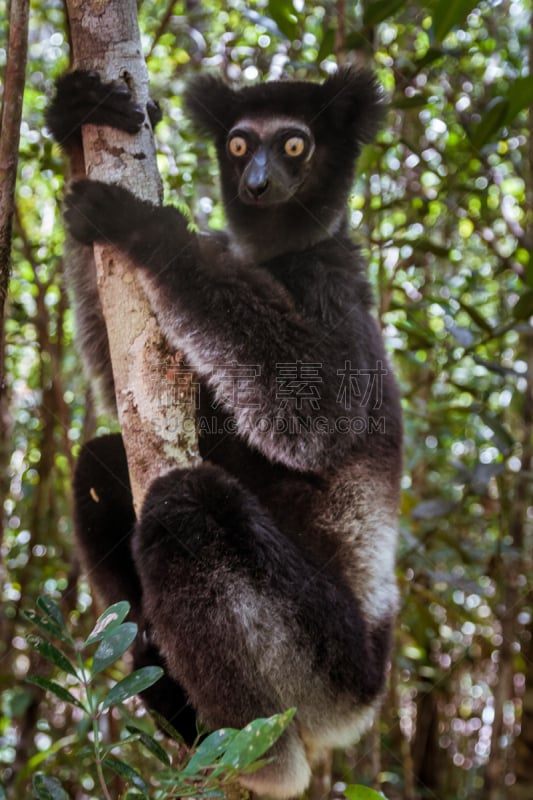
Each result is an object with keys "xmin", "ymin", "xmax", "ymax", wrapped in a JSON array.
[{"xmin": 184, "ymin": 75, "xmax": 239, "ymax": 138}]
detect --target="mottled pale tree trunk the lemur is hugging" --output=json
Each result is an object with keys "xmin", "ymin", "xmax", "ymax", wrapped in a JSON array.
[{"xmin": 67, "ymin": 0, "xmax": 198, "ymax": 512}]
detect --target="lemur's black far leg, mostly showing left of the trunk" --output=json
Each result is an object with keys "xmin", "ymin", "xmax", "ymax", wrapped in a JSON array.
[{"xmin": 74, "ymin": 434, "xmax": 197, "ymax": 744}]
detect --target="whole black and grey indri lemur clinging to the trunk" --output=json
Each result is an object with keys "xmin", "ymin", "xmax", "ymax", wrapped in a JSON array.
[{"xmin": 47, "ymin": 69, "xmax": 401, "ymax": 798}]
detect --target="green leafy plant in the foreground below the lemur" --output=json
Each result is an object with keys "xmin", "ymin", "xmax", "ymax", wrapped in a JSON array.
[{"xmin": 25, "ymin": 596, "xmax": 296, "ymax": 800}]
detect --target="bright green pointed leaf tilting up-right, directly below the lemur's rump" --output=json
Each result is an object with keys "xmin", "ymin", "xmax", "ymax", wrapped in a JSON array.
[{"xmin": 213, "ymin": 708, "xmax": 296, "ymax": 776}]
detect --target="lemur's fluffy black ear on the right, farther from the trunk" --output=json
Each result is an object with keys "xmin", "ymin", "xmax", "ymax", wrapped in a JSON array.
[{"xmin": 322, "ymin": 67, "xmax": 385, "ymax": 144}]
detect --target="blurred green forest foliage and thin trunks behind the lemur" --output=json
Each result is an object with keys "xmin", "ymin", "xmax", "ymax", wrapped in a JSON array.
[{"xmin": 0, "ymin": 0, "xmax": 533, "ymax": 800}]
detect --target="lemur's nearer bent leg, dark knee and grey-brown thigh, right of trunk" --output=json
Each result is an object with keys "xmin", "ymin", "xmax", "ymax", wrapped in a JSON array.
[{"xmin": 133, "ymin": 463, "xmax": 389, "ymax": 797}]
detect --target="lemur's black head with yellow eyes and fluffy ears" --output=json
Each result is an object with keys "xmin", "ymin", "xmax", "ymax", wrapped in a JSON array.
[{"xmin": 185, "ymin": 68, "xmax": 382, "ymax": 256}]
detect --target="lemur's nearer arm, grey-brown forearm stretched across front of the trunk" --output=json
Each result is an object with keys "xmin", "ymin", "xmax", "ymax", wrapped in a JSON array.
[{"xmin": 65, "ymin": 181, "xmax": 378, "ymax": 471}]
